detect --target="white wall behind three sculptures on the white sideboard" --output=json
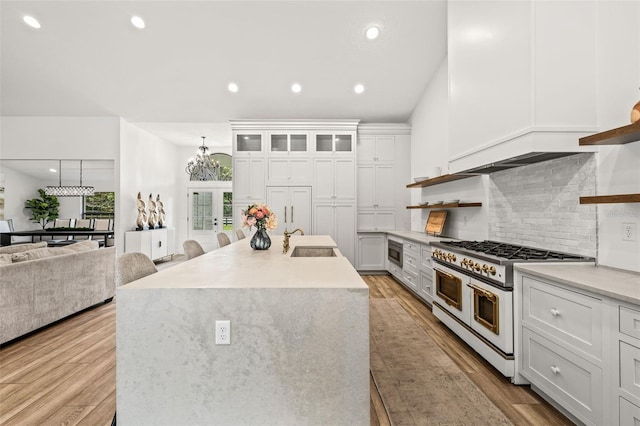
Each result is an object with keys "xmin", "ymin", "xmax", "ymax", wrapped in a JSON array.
[{"xmin": 116, "ymin": 120, "xmax": 180, "ymax": 253}]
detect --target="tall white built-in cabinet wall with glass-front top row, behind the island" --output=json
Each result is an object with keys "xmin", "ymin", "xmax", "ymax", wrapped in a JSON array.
[{"xmin": 230, "ymin": 120, "xmax": 358, "ymax": 265}]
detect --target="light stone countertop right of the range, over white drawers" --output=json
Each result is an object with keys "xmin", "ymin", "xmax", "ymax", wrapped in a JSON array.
[{"xmin": 515, "ymin": 263, "xmax": 640, "ymax": 305}]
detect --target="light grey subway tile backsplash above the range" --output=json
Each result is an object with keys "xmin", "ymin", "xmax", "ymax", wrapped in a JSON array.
[{"xmin": 488, "ymin": 153, "xmax": 597, "ymax": 257}]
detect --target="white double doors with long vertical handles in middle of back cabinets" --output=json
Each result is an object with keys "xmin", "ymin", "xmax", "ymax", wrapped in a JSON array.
[{"xmin": 267, "ymin": 186, "xmax": 312, "ymax": 234}]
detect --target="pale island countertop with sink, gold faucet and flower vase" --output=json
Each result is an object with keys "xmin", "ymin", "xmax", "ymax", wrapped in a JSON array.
[{"xmin": 117, "ymin": 235, "xmax": 368, "ymax": 291}]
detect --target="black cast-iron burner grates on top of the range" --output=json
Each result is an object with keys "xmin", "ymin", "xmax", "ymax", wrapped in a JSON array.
[{"xmin": 440, "ymin": 240, "xmax": 590, "ymax": 260}]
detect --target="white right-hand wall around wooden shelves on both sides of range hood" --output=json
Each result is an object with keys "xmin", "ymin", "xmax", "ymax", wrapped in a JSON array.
[{"xmin": 410, "ymin": 1, "xmax": 640, "ymax": 271}]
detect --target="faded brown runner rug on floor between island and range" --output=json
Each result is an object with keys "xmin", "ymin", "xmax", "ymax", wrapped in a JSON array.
[{"xmin": 369, "ymin": 299, "xmax": 512, "ymax": 426}]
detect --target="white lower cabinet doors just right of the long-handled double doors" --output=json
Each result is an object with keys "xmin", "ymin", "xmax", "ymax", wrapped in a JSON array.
[{"xmin": 313, "ymin": 202, "xmax": 356, "ymax": 265}]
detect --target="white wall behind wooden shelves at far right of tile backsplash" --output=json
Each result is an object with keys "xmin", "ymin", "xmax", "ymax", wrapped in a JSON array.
[{"xmin": 597, "ymin": 1, "xmax": 640, "ymax": 272}]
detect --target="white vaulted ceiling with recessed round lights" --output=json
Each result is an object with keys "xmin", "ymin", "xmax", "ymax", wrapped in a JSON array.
[{"xmin": 0, "ymin": 0, "xmax": 446, "ymax": 143}]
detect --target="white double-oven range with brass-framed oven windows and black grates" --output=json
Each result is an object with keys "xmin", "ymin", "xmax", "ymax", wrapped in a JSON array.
[{"xmin": 431, "ymin": 241, "xmax": 594, "ymax": 377}]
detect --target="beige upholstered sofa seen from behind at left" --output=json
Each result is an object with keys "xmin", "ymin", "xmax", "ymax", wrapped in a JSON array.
[{"xmin": 0, "ymin": 240, "xmax": 115, "ymax": 345}]
